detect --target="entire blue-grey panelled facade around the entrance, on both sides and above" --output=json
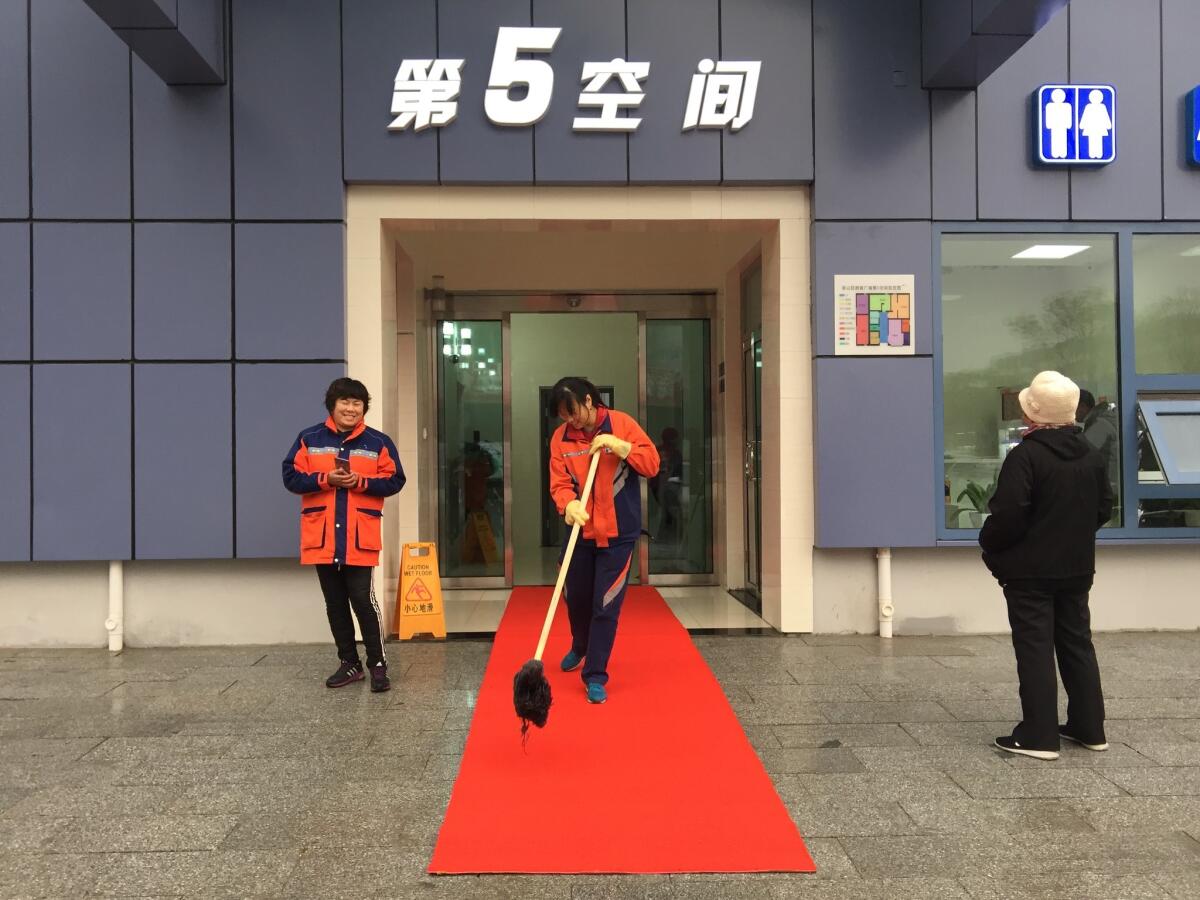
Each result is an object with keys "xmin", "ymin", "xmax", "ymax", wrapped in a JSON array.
[{"xmin": 0, "ymin": 0, "xmax": 1200, "ymax": 559}]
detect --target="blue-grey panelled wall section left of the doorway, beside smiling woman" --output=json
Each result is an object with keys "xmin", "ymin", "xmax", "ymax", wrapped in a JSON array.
[{"xmin": 7, "ymin": 0, "xmax": 344, "ymax": 560}]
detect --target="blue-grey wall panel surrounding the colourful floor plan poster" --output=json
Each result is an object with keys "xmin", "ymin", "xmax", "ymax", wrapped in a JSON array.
[{"xmin": 812, "ymin": 222, "xmax": 934, "ymax": 356}]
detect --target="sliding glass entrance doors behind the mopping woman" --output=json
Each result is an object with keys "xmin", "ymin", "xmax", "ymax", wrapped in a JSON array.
[{"xmin": 428, "ymin": 294, "xmax": 716, "ymax": 587}]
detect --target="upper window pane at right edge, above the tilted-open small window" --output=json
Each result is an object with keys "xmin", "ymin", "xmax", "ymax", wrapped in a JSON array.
[{"xmin": 1133, "ymin": 234, "xmax": 1200, "ymax": 374}]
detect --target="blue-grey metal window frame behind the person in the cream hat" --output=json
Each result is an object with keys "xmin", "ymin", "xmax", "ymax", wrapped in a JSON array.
[{"xmin": 930, "ymin": 221, "xmax": 1200, "ymax": 547}]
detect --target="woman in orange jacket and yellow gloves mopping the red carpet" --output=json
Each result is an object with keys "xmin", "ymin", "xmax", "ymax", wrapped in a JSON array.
[{"xmin": 550, "ymin": 378, "xmax": 659, "ymax": 703}]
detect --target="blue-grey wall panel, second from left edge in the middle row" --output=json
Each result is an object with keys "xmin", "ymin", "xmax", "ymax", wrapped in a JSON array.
[{"xmin": 34, "ymin": 222, "xmax": 132, "ymax": 360}]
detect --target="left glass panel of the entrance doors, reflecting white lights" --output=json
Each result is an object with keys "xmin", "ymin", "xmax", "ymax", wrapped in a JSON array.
[{"xmin": 437, "ymin": 320, "xmax": 505, "ymax": 578}]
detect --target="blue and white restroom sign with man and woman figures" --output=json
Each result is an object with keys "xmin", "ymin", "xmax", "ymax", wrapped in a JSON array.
[{"xmin": 1033, "ymin": 84, "xmax": 1117, "ymax": 166}]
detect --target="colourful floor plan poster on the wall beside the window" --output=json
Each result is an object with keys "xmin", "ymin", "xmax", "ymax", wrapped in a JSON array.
[{"xmin": 833, "ymin": 275, "xmax": 917, "ymax": 356}]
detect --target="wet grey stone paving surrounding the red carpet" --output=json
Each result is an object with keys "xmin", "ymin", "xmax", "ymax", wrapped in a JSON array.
[{"xmin": 0, "ymin": 632, "xmax": 1200, "ymax": 900}]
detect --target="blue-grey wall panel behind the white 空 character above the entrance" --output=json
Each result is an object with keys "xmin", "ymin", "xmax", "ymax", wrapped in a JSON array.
[{"xmin": 533, "ymin": 0, "xmax": 628, "ymax": 184}]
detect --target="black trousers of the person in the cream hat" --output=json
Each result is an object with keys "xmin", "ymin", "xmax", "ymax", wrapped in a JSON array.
[{"xmin": 1004, "ymin": 576, "xmax": 1104, "ymax": 750}]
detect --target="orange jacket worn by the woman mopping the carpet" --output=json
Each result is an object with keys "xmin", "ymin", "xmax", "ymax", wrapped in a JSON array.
[{"xmin": 550, "ymin": 407, "xmax": 659, "ymax": 547}]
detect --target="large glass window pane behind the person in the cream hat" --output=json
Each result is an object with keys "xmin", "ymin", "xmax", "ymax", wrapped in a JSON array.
[{"xmin": 941, "ymin": 234, "xmax": 1121, "ymax": 529}]
